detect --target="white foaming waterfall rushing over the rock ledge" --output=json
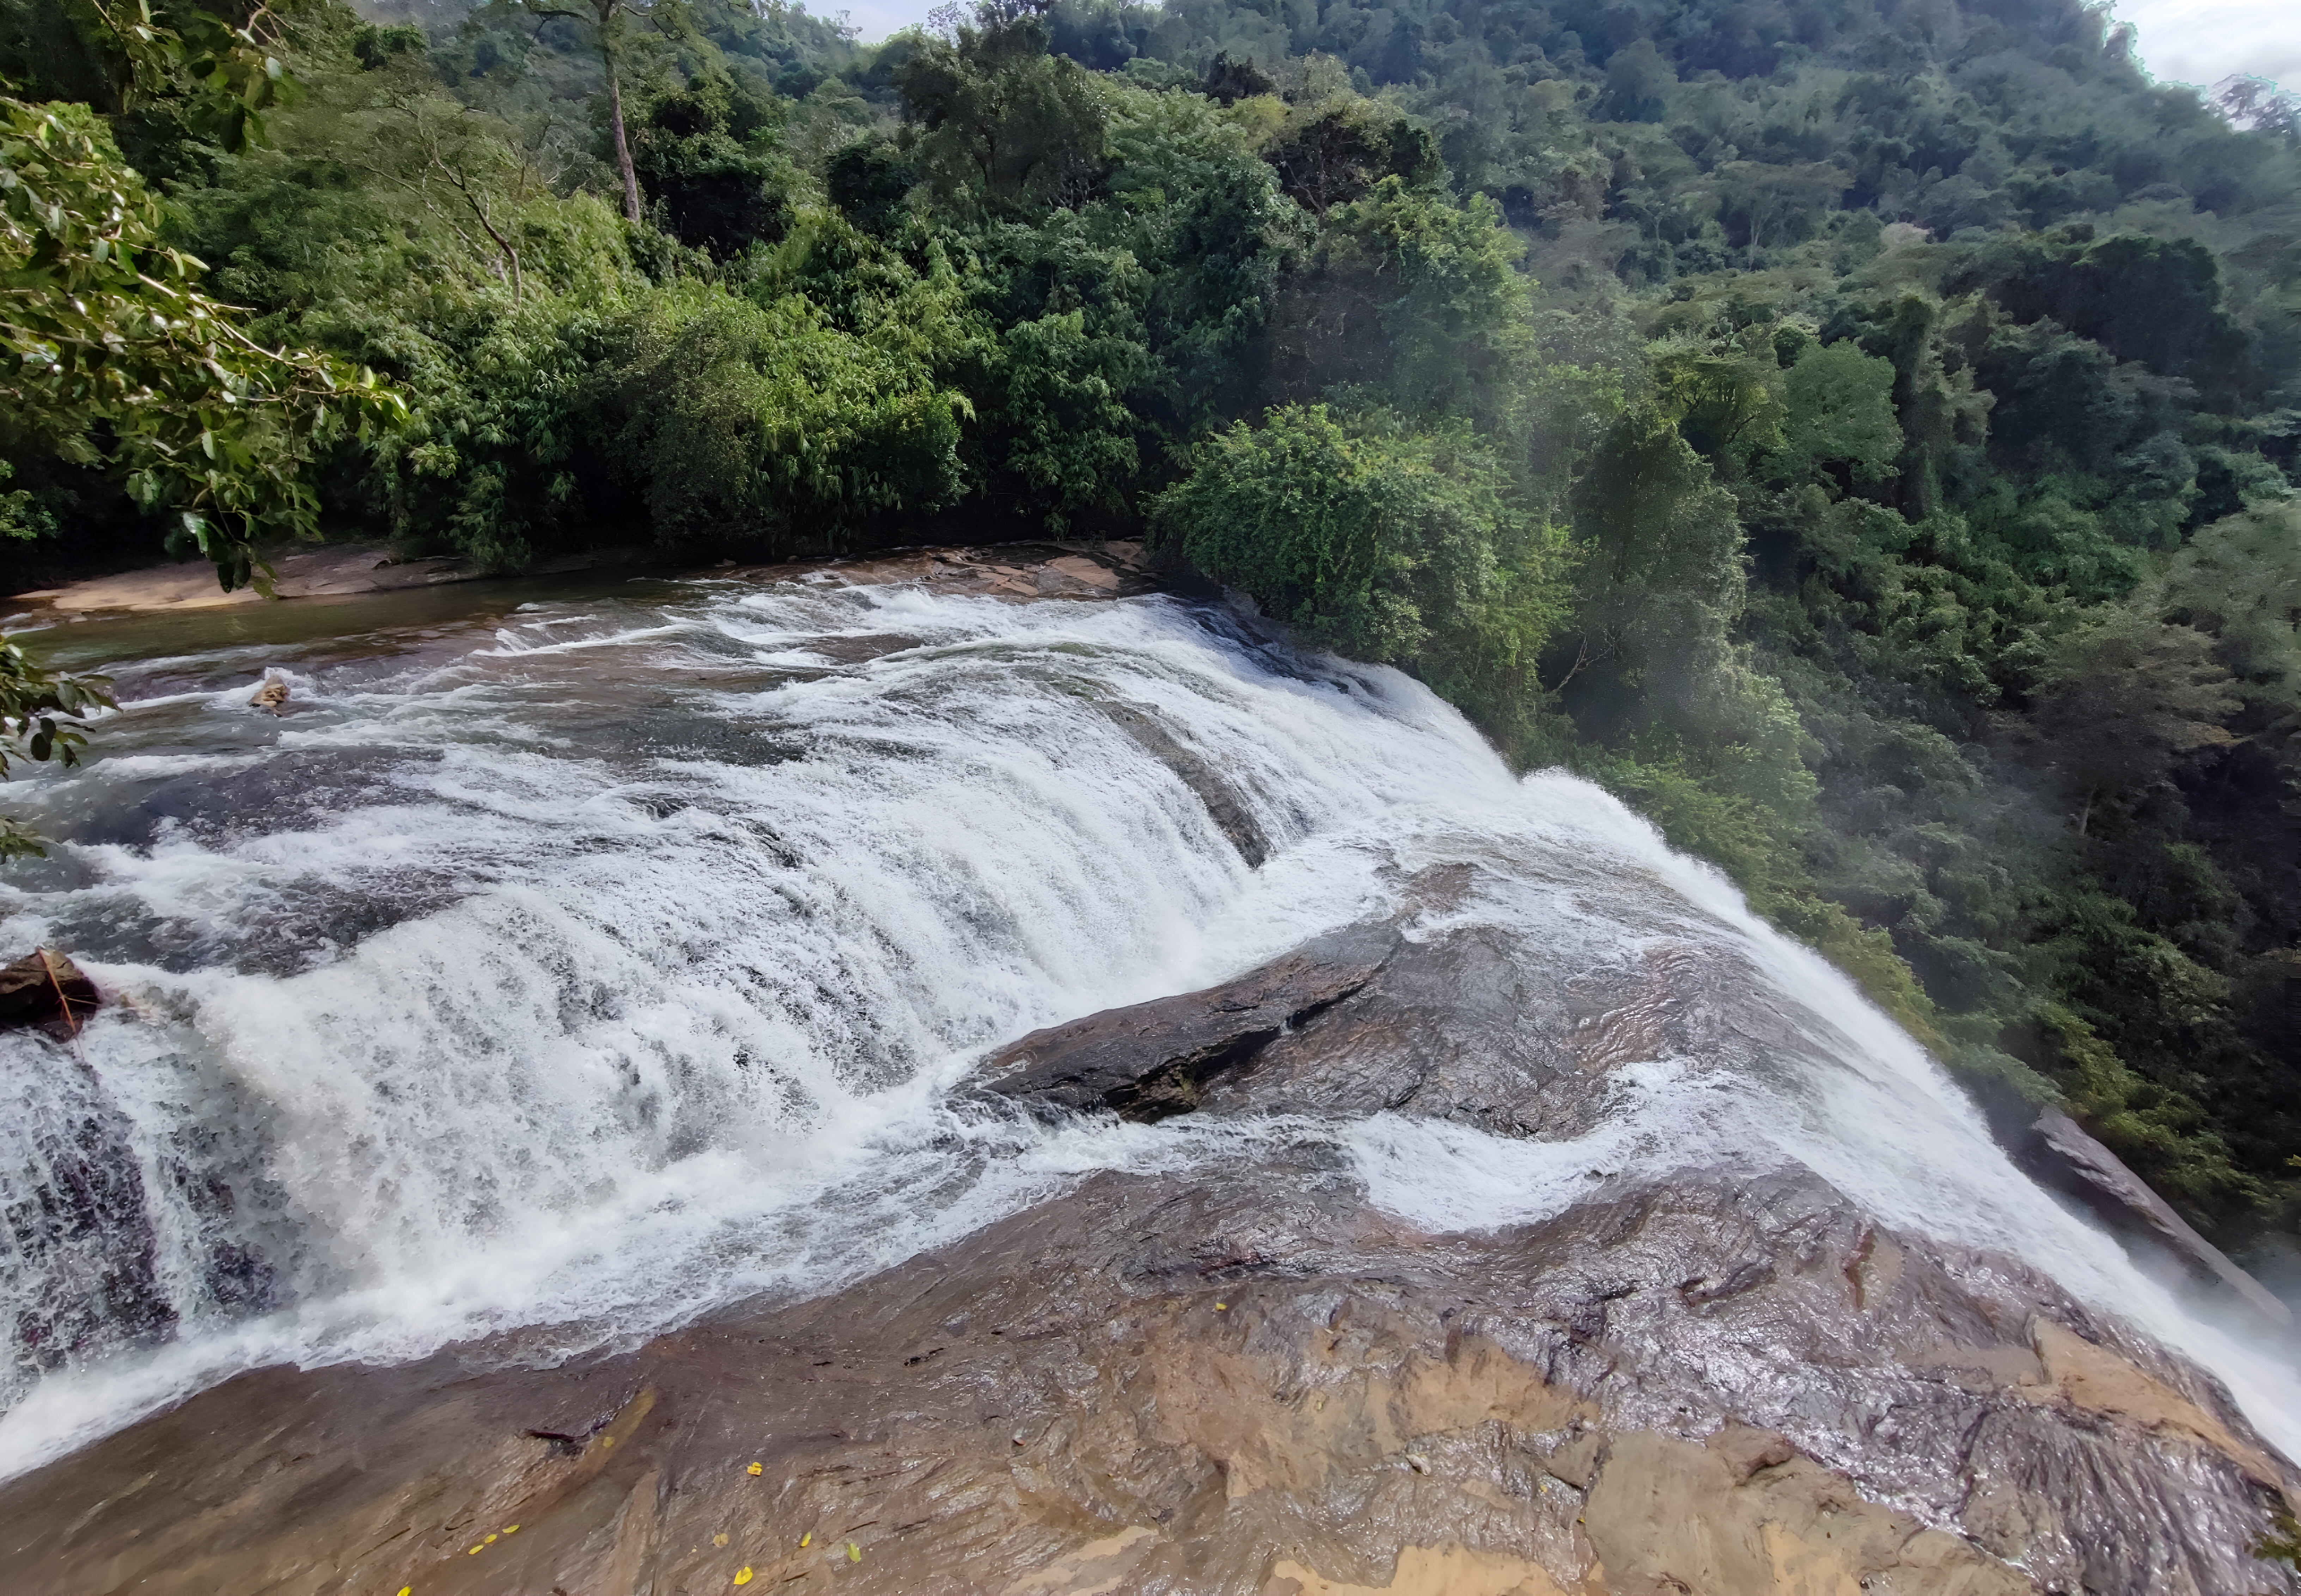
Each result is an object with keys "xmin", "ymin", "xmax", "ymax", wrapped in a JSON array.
[{"xmin": 0, "ymin": 582, "xmax": 2301, "ymax": 1474}]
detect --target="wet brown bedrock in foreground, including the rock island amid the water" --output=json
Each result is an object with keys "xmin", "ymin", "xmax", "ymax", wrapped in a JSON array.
[{"xmin": 0, "ymin": 910, "xmax": 2301, "ymax": 1596}]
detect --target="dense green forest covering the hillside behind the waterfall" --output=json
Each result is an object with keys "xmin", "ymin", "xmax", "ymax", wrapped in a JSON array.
[{"xmin": 0, "ymin": 0, "xmax": 2301, "ymax": 1260}]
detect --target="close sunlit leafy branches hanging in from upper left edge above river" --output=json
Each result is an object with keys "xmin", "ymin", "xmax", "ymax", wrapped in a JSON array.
[{"xmin": 0, "ymin": 99, "xmax": 405, "ymax": 589}]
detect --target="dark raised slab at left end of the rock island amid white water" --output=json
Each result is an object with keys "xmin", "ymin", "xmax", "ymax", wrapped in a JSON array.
[{"xmin": 983, "ymin": 927, "xmax": 1399, "ymax": 1120}]
